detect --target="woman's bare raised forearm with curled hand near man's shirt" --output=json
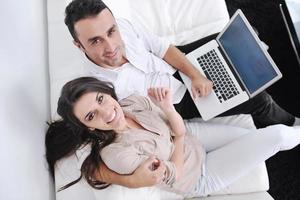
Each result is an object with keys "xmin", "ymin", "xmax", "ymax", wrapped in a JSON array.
[{"xmin": 148, "ymin": 88, "xmax": 186, "ymax": 180}]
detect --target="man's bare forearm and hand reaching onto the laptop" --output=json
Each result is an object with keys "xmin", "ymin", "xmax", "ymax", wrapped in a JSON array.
[{"xmin": 163, "ymin": 45, "xmax": 213, "ymax": 98}]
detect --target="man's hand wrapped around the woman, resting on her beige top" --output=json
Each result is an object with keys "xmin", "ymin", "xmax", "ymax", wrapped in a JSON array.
[{"xmin": 130, "ymin": 156, "xmax": 166, "ymax": 188}]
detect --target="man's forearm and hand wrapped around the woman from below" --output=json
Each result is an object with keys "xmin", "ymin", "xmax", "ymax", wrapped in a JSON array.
[{"xmin": 95, "ymin": 157, "xmax": 166, "ymax": 188}]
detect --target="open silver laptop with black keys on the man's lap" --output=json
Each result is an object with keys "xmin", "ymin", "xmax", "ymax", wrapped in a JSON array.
[{"xmin": 180, "ymin": 9, "xmax": 282, "ymax": 120}]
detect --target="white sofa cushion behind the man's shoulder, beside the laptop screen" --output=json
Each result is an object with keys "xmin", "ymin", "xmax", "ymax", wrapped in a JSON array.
[{"xmin": 104, "ymin": 0, "xmax": 229, "ymax": 45}]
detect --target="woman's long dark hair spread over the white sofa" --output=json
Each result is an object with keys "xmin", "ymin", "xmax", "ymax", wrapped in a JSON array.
[{"xmin": 45, "ymin": 77, "xmax": 117, "ymax": 190}]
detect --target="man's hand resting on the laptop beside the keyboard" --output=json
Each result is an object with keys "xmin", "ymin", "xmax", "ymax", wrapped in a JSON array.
[{"xmin": 191, "ymin": 74, "xmax": 213, "ymax": 99}]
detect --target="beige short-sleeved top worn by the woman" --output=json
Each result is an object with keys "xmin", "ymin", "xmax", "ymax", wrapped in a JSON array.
[{"xmin": 101, "ymin": 95, "xmax": 205, "ymax": 194}]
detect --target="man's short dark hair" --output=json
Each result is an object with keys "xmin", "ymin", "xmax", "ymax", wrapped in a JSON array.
[{"xmin": 65, "ymin": 0, "xmax": 110, "ymax": 41}]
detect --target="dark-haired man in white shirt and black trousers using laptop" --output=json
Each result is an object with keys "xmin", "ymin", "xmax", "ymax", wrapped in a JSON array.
[{"xmin": 65, "ymin": 0, "xmax": 299, "ymax": 128}]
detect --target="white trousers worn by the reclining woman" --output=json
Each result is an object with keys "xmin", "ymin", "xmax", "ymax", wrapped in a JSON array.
[{"xmin": 186, "ymin": 122, "xmax": 300, "ymax": 197}]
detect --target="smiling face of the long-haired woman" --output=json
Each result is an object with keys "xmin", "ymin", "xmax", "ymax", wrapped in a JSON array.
[{"xmin": 74, "ymin": 92, "xmax": 126, "ymax": 131}]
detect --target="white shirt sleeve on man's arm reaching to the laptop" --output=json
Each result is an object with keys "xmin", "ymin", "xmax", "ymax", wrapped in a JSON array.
[{"xmin": 129, "ymin": 21, "xmax": 170, "ymax": 58}]
